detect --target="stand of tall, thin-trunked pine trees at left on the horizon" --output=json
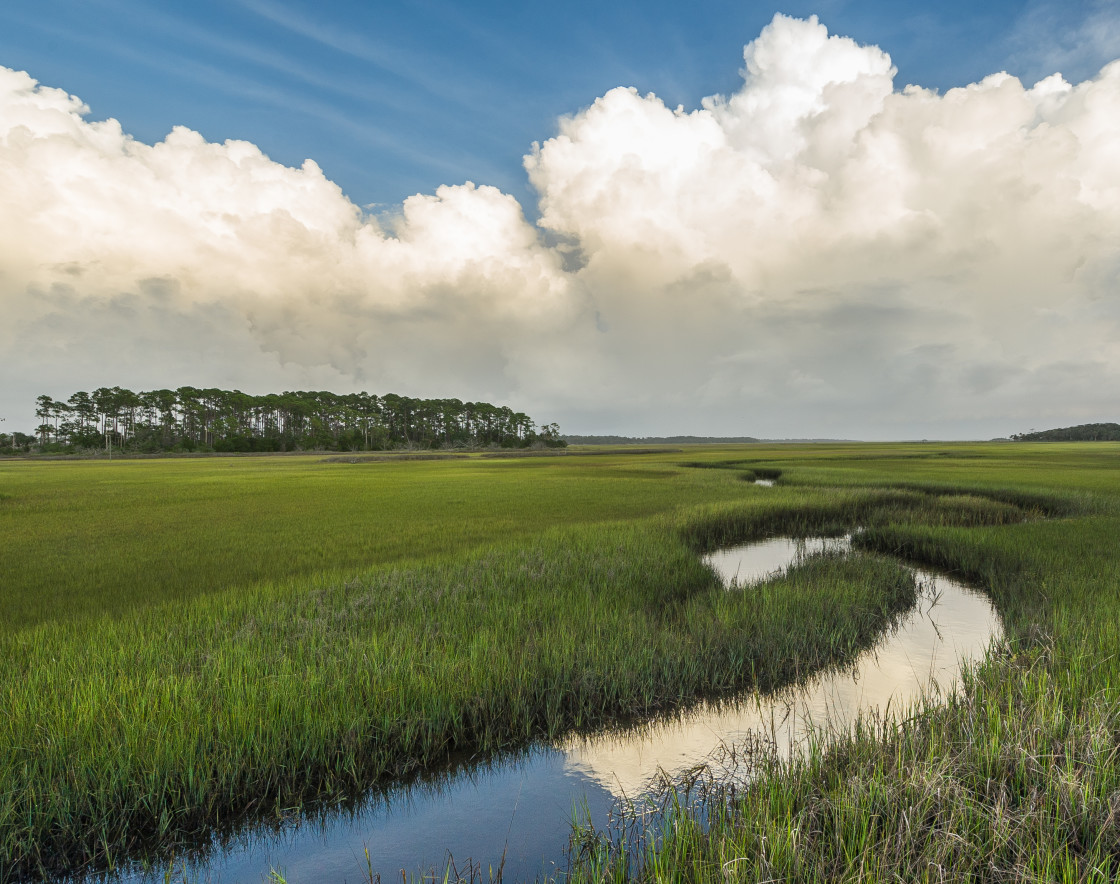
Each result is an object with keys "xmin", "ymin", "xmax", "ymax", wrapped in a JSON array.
[{"xmin": 0, "ymin": 387, "xmax": 564, "ymax": 453}]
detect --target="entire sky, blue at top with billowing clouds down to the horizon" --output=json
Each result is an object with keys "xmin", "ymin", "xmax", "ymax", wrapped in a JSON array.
[{"xmin": 0, "ymin": 0, "xmax": 1120, "ymax": 439}]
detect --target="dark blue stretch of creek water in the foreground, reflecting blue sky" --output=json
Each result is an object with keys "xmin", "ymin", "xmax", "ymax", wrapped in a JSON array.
[{"xmin": 117, "ymin": 747, "xmax": 615, "ymax": 884}]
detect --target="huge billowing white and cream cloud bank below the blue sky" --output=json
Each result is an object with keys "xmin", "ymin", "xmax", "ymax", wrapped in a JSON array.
[{"xmin": 0, "ymin": 16, "xmax": 1120, "ymax": 437}]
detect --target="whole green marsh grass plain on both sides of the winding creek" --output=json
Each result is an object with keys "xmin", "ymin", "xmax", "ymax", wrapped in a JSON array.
[{"xmin": 0, "ymin": 445, "xmax": 1120, "ymax": 881}]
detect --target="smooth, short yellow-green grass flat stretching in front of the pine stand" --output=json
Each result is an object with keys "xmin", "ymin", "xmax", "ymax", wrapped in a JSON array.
[{"xmin": 0, "ymin": 456, "xmax": 741, "ymax": 629}]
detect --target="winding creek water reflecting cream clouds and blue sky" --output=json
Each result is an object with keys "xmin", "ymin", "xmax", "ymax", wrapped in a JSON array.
[{"xmin": 103, "ymin": 538, "xmax": 1000, "ymax": 884}]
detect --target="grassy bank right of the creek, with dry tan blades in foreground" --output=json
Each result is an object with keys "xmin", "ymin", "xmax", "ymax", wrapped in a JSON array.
[{"xmin": 572, "ymin": 446, "xmax": 1120, "ymax": 883}]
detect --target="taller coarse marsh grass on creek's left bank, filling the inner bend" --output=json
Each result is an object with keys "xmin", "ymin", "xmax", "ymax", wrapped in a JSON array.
[{"xmin": 0, "ymin": 517, "xmax": 914, "ymax": 871}]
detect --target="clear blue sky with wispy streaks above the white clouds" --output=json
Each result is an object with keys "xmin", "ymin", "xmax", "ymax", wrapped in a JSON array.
[{"xmin": 0, "ymin": 0, "xmax": 1120, "ymax": 212}]
